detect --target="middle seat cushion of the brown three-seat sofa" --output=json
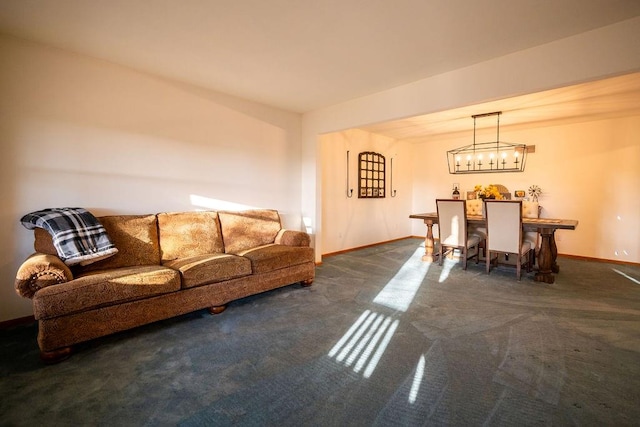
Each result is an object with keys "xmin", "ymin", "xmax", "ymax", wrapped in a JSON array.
[{"xmin": 163, "ymin": 253, "xmax": 251, "ymax": 288}]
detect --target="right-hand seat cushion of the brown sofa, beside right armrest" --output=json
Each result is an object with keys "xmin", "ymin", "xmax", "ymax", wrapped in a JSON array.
[{"xmin": 238, "ymin": 244, "xmax": 314, "ymax": 274}]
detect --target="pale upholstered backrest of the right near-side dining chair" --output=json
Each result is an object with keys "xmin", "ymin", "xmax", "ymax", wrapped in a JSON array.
[{"xmin": 485, "ymin": 200, "xmax": 522, "ymax": 254}]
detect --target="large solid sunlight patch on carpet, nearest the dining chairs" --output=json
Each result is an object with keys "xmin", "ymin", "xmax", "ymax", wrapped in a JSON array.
[{"xmin": 373, "ymin": 247, "xmax": 431, "ymax": 311}]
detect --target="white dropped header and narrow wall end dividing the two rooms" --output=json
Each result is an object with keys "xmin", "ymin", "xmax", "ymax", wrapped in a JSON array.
[{"xmin": 302, "ymin": 17, "xmax": 640, "ymax": 261}]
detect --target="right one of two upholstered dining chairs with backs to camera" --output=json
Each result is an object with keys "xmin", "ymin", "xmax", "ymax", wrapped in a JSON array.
[{"xmin": 484, "ymin": 200, "xmax": 531, "ymax": 280}]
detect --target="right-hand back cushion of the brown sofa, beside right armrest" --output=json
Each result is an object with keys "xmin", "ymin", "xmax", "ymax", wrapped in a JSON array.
[{"xmin": 218, "ymin": 209, "xmax": 282, "ymax": 254}]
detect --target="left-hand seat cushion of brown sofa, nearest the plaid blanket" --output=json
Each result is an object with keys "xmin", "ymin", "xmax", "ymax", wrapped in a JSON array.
[{"xmin": 33, "ymin": 265, "xmax": 180, "ymax": 321}]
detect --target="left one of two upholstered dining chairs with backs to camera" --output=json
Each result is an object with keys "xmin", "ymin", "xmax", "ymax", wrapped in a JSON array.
[{"xmin": 436, "ymin": 199, "xmax": 482, "ymax": 270}]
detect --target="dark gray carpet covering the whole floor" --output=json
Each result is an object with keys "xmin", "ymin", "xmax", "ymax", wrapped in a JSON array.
[{"xmin": 0, "ymin": 239, "xmax": 640, "ymax": 426}]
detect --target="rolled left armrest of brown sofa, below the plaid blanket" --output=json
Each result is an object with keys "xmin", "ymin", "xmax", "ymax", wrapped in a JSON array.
[{"xmin": 15, "ymin": 252, "xmax": 73, "ymax": 298}]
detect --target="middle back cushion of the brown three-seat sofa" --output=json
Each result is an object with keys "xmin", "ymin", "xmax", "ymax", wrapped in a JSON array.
[{"xmin": 158, "ymin": 211, "xmax": 224, "ymax": 262}]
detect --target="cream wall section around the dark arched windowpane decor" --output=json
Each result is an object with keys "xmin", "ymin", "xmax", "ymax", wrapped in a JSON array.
[{"xmin": 320, "ymin": 129, "xmax": 412, "ymax": 254}]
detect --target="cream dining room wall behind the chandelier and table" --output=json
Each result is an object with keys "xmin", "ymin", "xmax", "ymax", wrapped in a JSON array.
[{"xmin": 412, "ymin": 116, "xmax": 640, "ymax": 263}]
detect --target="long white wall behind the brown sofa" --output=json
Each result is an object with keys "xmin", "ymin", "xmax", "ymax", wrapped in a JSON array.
[{"xmin": 0, "ymin": 37, "xmax": 302, "ymax": 321}]
